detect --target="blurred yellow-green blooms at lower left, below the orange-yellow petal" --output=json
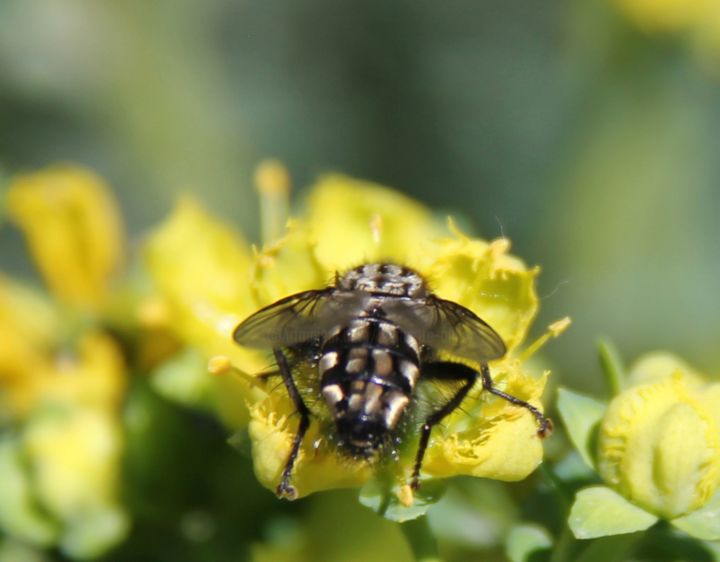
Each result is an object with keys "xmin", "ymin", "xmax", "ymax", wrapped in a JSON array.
[{"xmin": 0, "ymin": 324, "xmax": 128, "ymax": 557}]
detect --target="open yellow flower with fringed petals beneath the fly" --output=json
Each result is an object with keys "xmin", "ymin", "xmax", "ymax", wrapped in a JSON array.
[{"xmin": 146, "ymin": 166, "xmax": 564, "ymax": 496}]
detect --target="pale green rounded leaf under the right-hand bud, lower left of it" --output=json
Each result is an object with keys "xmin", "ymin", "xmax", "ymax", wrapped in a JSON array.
[{"xmin": 568, "ymin": 486, "xmax": 658, "ymax": 539}]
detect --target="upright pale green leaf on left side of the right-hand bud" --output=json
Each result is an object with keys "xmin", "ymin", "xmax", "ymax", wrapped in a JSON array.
[{"xmin": 557, "ymin": 388, "xmax": 607, "ymax": 468}]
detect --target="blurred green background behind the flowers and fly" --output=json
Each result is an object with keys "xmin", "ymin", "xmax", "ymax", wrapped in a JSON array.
[{"xmin": 0, "ymin": 0, "xmax": 720, "ymax": 560}]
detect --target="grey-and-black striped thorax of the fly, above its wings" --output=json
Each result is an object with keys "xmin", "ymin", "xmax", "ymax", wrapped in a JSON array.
[{"xmin": 336, "ymin": 263, "xmax": 428, "ymax": 298}]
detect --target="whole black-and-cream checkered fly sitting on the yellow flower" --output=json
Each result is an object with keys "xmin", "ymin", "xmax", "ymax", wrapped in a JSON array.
[{"xmin": 233, "ymin": 263, "xmax": 552, "ymax": 499}]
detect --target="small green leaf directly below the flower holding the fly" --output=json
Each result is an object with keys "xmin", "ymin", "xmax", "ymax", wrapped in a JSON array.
[{"xmin": 358, "ymin": 478, "xmax": 445, "ymax": 523}]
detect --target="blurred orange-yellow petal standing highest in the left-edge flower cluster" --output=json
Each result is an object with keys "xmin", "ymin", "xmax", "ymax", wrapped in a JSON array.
[{"xmin": 7, "ymin": 166, "xmax": 123, "ymax": 309}]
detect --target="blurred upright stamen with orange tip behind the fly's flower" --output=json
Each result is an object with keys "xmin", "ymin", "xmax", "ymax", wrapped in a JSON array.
[{"xmin": 255, "ymin": 160, "xmax": 290, "ymax": 245}]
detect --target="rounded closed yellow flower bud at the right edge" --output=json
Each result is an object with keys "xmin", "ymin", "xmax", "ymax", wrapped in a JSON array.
[{"xmin": 598, "ymin": 354, "xmax": 720, "ymax": 519}]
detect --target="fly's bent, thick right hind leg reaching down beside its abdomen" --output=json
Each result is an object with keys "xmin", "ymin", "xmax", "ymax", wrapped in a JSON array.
[{"xmin": 410, "ymin": 361, "xmax": 477, "ymax": 490}]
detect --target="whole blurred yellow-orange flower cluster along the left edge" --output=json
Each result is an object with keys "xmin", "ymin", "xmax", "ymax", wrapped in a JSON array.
[{"xmin": 0, "ymin": 167, "xmax": 128, "ymax": 557}]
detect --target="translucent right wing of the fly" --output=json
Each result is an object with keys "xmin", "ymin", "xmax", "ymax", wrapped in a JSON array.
[{"xmin": 382, "ymin": 296, "xmax": 506, "ymax": 362}]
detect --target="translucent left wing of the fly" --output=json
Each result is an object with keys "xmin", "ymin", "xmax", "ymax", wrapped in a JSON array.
[{"xmin": 233, "ymin": 287, "xmax": 365, "ymax": 348}]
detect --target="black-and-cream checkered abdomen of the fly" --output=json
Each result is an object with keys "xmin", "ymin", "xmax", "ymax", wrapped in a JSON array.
[{"xmin": 318, "ymin": 317, "xmax": 420, "ymax": 454}]
